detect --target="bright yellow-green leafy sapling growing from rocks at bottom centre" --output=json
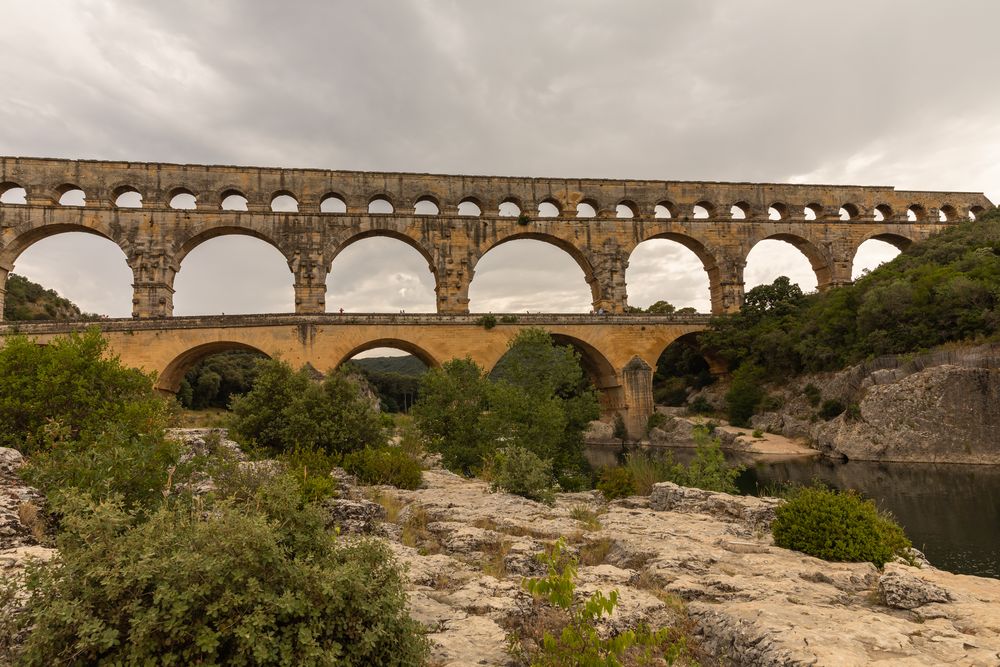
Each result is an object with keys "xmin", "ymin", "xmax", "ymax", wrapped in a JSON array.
[{"xmin": 522, "ymin": 538, "xmax": 684, "ymax": 667}]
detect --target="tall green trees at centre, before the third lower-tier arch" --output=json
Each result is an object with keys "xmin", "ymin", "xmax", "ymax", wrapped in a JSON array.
[{"xmin": 413, "ymin": 329, "xmax": 600, "ymax": 486}]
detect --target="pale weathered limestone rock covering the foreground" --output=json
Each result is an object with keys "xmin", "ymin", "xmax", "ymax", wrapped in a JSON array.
[{"xmin": 0, "ymin": 436, "xmax": 1000, "ymax": 666}]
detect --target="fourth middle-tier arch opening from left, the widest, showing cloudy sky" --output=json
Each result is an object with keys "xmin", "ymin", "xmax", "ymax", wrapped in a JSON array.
[{"xmin": 469, "ymin": 237, "xmax": 594, "ymax": 313}]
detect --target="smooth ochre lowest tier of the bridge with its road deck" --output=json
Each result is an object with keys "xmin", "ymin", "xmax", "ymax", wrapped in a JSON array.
[{"xmin": 0, "ymin": 313, "xmax": 721, "ymax": 436}]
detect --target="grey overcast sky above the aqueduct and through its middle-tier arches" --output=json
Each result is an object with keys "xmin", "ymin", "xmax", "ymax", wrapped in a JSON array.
[{"xmin": 0, "ymin": 0, "xmax": 1000, "ymax": 324}]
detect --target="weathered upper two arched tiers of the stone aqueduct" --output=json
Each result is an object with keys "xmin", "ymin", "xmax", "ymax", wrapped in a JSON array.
[{"xmin": 0, "ymin": 157, "xmax": 993, "ymax": 317}]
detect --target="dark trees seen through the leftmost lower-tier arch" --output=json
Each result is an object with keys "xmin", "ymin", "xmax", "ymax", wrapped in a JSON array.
[{"xmin": 177, "ymin": 350, "xmax": 264, "ymax": 410}]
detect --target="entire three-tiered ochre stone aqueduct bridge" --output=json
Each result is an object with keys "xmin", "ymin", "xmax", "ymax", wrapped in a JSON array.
[{"xmin": 0, "ymin": 157, "xmax": 993, "ymax": 436}]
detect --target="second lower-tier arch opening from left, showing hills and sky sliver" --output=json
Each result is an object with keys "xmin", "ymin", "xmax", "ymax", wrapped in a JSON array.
[{"xmin": 338, "ymin": 339, "xmax": 438, "ymax": 413}]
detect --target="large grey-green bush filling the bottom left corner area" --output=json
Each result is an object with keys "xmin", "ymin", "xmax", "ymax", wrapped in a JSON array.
[{"xmin": 7, "ymin": 485, "xmax": 427, "ymax": 667}]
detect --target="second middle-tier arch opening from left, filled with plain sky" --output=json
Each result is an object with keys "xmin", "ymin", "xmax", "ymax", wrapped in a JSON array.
[{"xmin": 174, "ymin": 230, "xmax": 295, "ymax": 315}]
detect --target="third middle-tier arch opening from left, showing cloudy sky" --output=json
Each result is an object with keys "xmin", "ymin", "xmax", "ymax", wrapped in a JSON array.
[{"xmin": 326, "ymin": 236, "xmax": 437, "ymax": 313}]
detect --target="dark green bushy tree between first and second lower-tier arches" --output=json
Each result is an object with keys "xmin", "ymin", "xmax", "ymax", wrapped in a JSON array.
[{"xmin": 232, "ymin": 360, "xmax": 387, "ymax": 454}]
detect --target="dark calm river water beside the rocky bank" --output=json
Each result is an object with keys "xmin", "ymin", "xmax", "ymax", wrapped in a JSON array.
[{"xmin": 587, "ymin": 446, "xmax": 1000, "ymax": 578}]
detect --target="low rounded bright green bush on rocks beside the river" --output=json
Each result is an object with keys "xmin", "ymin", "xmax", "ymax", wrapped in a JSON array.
[{"xmin": 771, "ymin": 485, "xmax": 912, "ymax": 567}]
